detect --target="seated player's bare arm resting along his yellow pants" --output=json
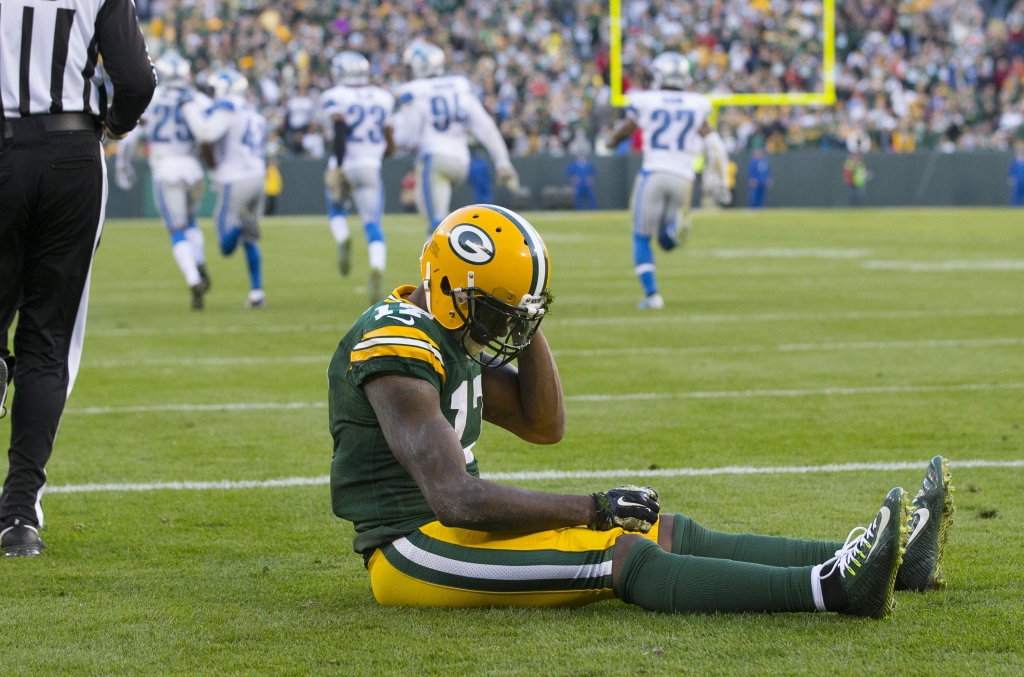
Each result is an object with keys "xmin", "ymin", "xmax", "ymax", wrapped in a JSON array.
[{"xmin": 365, "ymin": 376, "xmax": 597, "ymax": 532}]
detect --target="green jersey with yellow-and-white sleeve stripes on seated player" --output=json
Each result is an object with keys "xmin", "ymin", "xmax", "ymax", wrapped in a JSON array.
[{"xmin": 327, "ymin": 286, "xmax": 483, "ymax": 554}]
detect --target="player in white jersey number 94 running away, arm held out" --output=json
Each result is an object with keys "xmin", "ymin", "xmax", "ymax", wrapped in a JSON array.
[{"xmin": 395, "ymin": 41, "xmax": 519, "ymax": 235}]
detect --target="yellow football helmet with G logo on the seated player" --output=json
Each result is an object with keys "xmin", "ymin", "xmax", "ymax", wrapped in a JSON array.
[{"xmin": 420, "ymin": 205, "xmax": 551, "ymax": 367}]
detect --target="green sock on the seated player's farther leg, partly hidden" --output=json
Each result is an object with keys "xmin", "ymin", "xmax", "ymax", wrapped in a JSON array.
[{"xmin": 672, "ymin": 514, "xmax": 843, "ymax": 566}]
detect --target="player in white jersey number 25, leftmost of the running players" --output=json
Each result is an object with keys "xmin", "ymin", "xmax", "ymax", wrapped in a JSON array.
[{"xmin": 117, "ymin": 50, "xmax": 211, "ymax": 310}]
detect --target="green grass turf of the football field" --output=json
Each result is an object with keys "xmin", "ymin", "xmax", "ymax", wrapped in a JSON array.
[{"xmin": 0, "ymin": 210, "xmax": 1024, "ymax": 675}]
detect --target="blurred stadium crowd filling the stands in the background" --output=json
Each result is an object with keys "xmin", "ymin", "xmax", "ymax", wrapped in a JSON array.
[{"xmin": 151, "ymin": 0, "xmax": 1024, "ymax": 156}]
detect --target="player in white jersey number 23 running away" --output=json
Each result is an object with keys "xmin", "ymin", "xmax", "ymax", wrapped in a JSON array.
[{"xmin": 321, "ymin": 51, "xmax": 394, "ymax": 303}]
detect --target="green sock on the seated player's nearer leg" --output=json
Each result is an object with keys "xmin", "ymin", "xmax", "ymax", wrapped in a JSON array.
[{"xmin": 615, "ymin": 541, "xmax": 815, "ymax": 613}]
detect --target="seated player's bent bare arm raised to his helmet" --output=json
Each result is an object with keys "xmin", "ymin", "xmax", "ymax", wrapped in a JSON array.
[{"xmin": 483, "ymin": 329, "xmax": 565, "ymax": 445}]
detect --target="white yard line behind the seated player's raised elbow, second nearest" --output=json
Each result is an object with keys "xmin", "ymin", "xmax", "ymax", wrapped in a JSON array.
[{"xmin": 63, "ymin": 383, "xmax": 1024, "ymax": 416}]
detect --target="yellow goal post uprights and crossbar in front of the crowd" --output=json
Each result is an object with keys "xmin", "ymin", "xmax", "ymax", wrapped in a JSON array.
[{"xmin": 608, "ymin": 0, "xmax": 836, "ymax": 120}]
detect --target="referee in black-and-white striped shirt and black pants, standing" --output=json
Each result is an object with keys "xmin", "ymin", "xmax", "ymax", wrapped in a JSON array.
[{"xmin": 0, "ymin": 0, "xmax": 157, "ymax": 557}]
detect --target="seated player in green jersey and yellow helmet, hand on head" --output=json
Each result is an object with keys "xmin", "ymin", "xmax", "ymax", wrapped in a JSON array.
[{"xmin": 328, "ymin": 205, "xmax": 952, "ymax": 618}]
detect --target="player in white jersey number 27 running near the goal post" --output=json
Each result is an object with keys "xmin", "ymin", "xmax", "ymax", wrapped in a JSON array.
[{"xmin": 609, "ymin": 52, "xmax": 725, "ymax": 309}]
